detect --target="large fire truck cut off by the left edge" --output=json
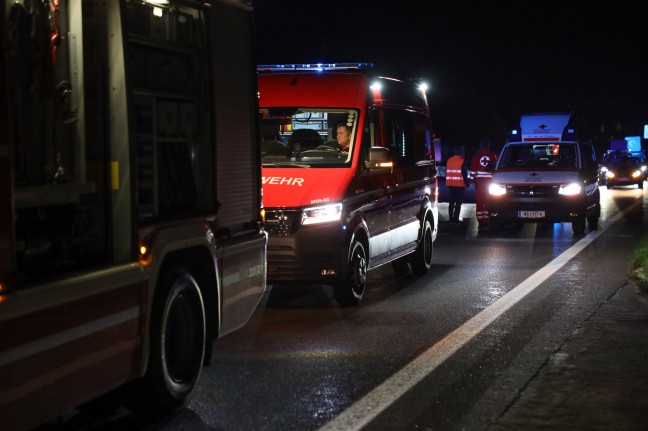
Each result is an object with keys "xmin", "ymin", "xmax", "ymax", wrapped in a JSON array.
[{"xmin": 0, "ymin": 0, "xmax": 267, "ymax": 431}]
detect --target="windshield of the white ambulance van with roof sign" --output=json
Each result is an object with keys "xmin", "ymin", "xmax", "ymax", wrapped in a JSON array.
[{"xmin": 497, "ymin": 142, "xmax": 578, "ymax": 169}]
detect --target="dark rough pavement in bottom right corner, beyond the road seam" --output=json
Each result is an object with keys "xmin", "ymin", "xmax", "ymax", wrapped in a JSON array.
[{"xmin": 489, "ymin": 282, "xmax": 648, "ymax": 431}]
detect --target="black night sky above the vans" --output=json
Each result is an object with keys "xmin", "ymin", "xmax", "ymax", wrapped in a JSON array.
[{"xmin": 254, "ymin": 0, "xmax": 648, "ymax": 151}]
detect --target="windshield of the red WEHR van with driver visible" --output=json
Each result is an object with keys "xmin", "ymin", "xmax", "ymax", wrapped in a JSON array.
[{"xmin": 260, "ymin": 107, "xmax": 359, "ymax": 167}]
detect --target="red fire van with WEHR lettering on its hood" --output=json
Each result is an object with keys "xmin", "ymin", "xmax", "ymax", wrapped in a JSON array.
[{"xmin": 257, "ymin": 64, "xmax": 438, "ymax": 306}]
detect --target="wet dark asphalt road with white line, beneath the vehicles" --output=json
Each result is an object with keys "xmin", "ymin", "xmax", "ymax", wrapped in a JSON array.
[{"xmin": 39, "ymin": 188, "xmax": 648, "ymax": 431}]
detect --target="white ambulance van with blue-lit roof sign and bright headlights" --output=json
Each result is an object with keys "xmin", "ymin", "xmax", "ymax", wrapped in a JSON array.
[{"xmin": 489, "ymin": 113, "xmax": 600, "ymax": 234}]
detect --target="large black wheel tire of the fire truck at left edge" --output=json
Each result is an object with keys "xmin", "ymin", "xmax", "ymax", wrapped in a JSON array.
[{"xmin": 126, "ymin": 270, "xmax": 207, "ymax": 417}]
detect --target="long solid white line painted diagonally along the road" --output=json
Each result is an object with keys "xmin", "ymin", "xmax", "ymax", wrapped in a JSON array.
[{"xmin": 320, "ymin": 201, "xmax": 642, "ymax": 431}]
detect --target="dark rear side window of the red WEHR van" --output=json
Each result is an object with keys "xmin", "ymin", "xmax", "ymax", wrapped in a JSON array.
[{"xmin": 384, "ymin": 109, "xmax": 431, "ymax": 167}]
